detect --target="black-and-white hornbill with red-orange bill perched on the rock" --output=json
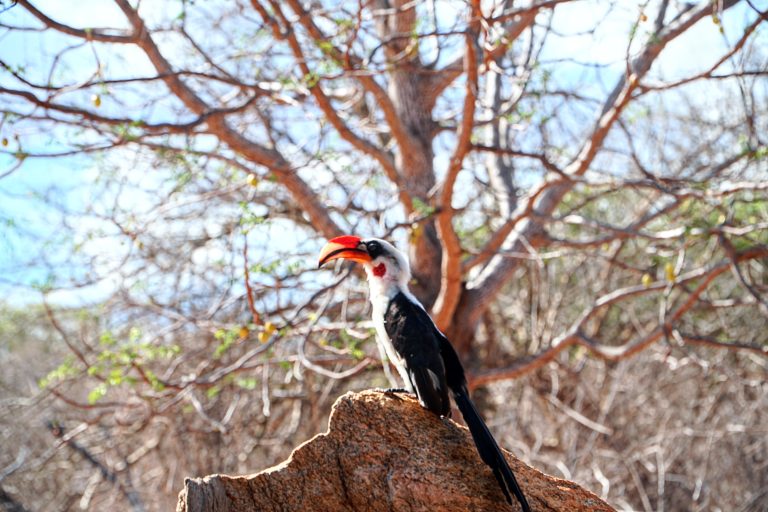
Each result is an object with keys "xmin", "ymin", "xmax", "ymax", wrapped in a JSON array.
[{"xmin": 319, "ymin": 235, "xmax": 530, "ymax": 512}]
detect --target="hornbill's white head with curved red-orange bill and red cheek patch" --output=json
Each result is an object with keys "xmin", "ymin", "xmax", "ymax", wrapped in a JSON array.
[{"xmin": 320, "ymin": 236, "xmax": 411, "ymax": 297}]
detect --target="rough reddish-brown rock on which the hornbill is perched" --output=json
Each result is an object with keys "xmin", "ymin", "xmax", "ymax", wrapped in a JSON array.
[{"xmin": 176, "ymin": 391, "xmax": 614, "ymax": 512}]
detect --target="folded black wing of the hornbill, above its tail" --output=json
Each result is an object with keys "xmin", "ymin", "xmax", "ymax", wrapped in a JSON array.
[{"xmin": 384, "ymin": 293, "xmax": 451, "ymax": 416}]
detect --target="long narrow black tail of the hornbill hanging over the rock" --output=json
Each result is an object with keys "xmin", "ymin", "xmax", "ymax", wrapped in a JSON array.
[{"xmin": 453, "ymin": 386, "xmax": 531, "ymax": 512}]
